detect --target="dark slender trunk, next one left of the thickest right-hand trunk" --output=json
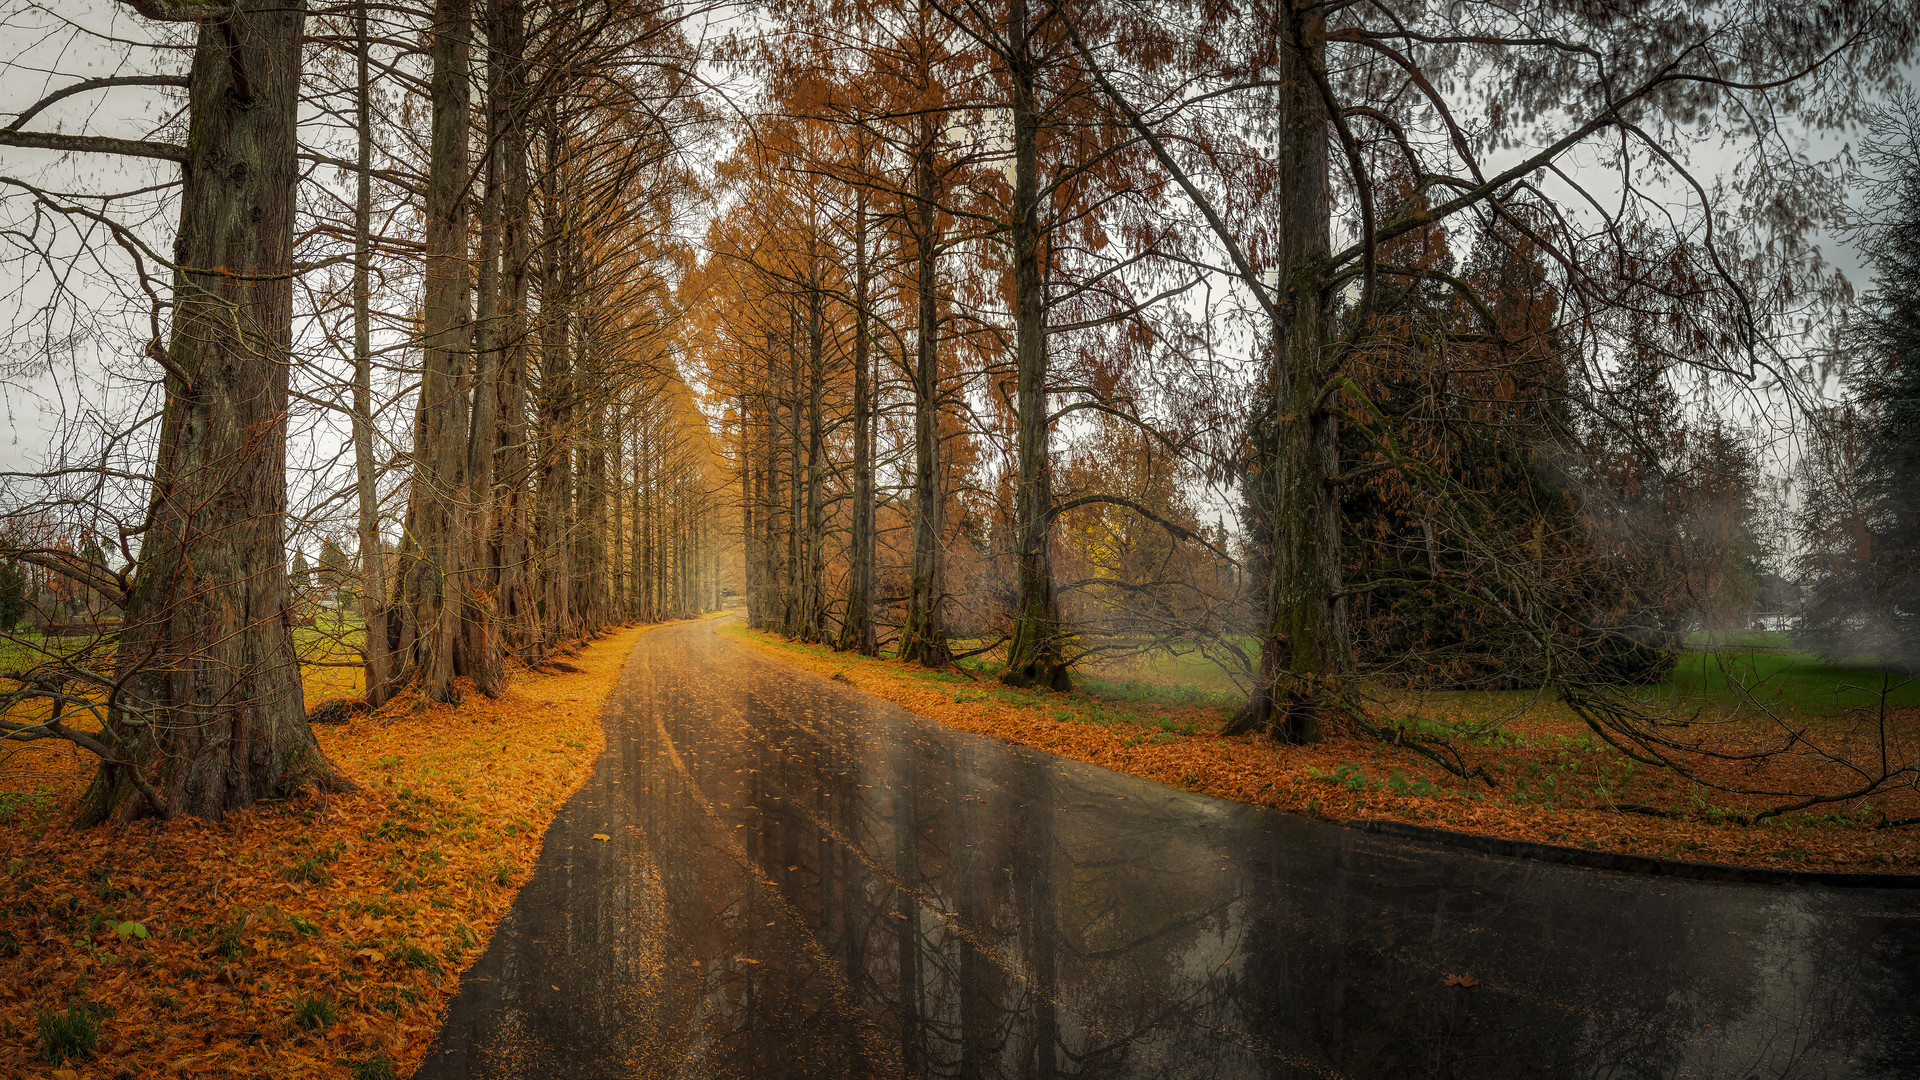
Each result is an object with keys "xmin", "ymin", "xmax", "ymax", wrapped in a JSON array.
[{"xmin": 1000, "ymin": 0, "xmax": 1073, "ymax": 690}]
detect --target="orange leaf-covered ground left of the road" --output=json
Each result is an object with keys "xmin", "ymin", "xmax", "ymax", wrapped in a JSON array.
[{"xmin": 0, "ymin": 626, "xmax": 653, "ymax": 1080}]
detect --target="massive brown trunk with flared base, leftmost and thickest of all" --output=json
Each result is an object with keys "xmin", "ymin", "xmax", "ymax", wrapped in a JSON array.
[{"xmin": 79, "ymin": 0, "xmax": 348, "ymax": 824}]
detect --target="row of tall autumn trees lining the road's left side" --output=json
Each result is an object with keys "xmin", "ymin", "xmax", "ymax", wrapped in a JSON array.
[{"xmin": 0, "ymin": 0, "xmax": 724, "ymax": 822}]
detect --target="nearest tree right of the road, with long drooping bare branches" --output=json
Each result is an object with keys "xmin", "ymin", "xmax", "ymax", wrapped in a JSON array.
[{"xmin": 1075, "ymin": 0, "xmax": 1914, "ymax": 757}]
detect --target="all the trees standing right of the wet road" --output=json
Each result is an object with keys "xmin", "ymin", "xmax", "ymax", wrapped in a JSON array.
[{"xmin": 699, "ymin": 0, "xmax": 1912, "ymax": 805}]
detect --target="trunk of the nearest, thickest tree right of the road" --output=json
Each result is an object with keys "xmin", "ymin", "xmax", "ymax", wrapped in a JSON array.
[{"xmin": 1231, "ymin": 10, "xmax": 1352, "ymax": 742}]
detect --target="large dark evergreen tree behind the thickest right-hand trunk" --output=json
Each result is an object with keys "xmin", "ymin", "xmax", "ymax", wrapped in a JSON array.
[{"xmin": 1340, "ymin": 220, "xmax": 1665, "ymax": 690}]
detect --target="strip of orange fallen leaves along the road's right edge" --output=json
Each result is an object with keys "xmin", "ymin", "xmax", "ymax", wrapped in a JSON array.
[{"xmin": 721, "ymin": 630, "xmax": 1920, "ymax": 872}]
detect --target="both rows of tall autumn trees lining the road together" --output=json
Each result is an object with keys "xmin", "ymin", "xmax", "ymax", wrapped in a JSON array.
[{"xmin": 0, "ymin": 0, "xmax": 1914, "ymax": 819}]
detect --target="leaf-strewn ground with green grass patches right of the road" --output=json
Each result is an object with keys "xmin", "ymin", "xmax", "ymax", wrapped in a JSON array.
[{"xmin": 724, "ymin": 625, "xmax": 1920, "ymax": 872}]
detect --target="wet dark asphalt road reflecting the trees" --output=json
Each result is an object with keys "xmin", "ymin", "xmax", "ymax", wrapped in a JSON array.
[{"xmin": 417, "ymin": 623, "xmax": 1920, "ymax": 1080}]
